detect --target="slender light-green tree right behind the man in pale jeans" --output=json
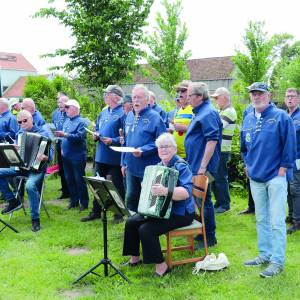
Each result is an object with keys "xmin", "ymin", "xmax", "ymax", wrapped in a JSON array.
[{"xmin": 232, "ymin": 21, "xmax": 292, "ymax": 101}]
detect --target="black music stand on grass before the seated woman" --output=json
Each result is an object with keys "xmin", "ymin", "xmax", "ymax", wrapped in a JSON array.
[{"xmin": 72, "ymin": 177, "xmax": 130, "ymax": 284}]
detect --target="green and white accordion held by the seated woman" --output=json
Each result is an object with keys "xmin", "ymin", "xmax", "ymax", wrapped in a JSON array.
[{"xmin": 138, "ymin": 165, "xmax": 179, "ymax": 219}]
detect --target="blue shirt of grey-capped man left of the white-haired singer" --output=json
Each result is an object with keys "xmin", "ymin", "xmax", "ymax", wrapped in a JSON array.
[{"xmin": 95, "ymin": 105, "xmax": 125, "ymax": 166}]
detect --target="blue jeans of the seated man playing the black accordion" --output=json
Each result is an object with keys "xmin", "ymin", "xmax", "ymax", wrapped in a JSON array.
[{"xmin": 0, "ymin": 168, "xmax": 45, "ymax": 219}]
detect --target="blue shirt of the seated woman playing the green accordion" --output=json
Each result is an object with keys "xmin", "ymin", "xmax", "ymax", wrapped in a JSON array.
[{"xmin": 167, "ymin": 155, "xmax": 195, "ymax": 216}]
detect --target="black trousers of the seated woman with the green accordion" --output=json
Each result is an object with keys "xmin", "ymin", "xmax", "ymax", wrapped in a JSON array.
[{"xmin": 123, "ymin": 214, "xmax": 195, "ymax": 264}]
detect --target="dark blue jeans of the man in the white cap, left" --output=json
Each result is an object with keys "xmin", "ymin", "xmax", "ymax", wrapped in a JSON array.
[{"xmin": 63, "ymin": 157, "xmax": 89, "ymax": 208}]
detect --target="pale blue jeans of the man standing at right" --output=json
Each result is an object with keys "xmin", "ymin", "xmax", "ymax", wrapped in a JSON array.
[{"xmin": 250, "ymin": 176, "xmax": 287, "ymax": 267}]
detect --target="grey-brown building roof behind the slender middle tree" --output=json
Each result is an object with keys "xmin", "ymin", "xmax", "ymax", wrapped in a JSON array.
[{"xmin": 133, "ymin": 56, "xmax": 234, "ymax": 83}]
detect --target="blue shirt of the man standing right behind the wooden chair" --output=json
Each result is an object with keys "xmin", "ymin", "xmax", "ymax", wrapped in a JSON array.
[{"xmin": 184, "ymin": 100, "xmax": 223, "ymax": 175}]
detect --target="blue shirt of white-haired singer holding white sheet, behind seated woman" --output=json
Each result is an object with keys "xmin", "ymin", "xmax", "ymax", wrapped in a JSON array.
[{"xmin": 122, "ymin": 107, "xmax": 166, "ymax": 178}]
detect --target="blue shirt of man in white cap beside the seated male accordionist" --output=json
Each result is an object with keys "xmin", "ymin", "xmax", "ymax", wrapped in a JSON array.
[{"xmin": 61, "ymin": 115, "xmax": 86, "ymax": 161}]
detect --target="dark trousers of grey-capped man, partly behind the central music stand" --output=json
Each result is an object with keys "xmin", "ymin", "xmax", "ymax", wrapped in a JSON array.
[{"xmin": 93, "ymin": 162, "xmax": 125, "ymax": 216}]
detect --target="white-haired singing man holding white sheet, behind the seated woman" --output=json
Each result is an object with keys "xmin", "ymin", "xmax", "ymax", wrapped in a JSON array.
[{"xmin": 122, "ymin": 85, "xmax": 166, "ymax": 212}]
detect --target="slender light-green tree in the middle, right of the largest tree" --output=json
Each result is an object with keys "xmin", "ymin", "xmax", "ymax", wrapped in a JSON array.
[{"xmin": 146, "ymin": 0, "xmax": 191, "ymax": 95}]
